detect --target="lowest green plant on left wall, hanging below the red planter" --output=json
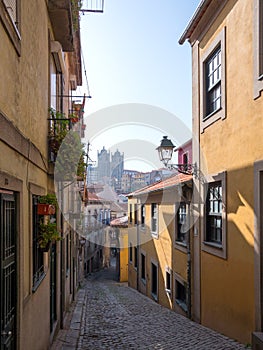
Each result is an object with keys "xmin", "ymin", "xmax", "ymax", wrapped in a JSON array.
[{"xmin": 38, "ymin": 222, "xmax": 62, "ymax": 252}]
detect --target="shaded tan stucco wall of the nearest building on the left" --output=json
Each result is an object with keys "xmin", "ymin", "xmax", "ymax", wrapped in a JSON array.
[{"xmin": 0, "ymin": 1, "xmax": 78, "ymax": 350}]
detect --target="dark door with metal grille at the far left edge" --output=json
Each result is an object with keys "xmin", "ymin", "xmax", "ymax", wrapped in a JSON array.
[{"xmin": 0, "ymin": 190, "xmax": 17, "ymax": 350}]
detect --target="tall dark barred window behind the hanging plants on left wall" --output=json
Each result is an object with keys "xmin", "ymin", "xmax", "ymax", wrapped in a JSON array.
[{"xmin": 32, "ymin": 196, "xmax": 45, "ymax": 291}]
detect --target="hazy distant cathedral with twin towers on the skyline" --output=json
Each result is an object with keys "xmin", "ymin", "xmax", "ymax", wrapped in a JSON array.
[{"xmin": 97, "ymin": 147, "xmax": 124, "ymax": 190}]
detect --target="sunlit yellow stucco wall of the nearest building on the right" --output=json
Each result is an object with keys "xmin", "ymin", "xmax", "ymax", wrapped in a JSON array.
[{"xmin": 199, "ymin": 1, "xmax": 263, "ymax": 343}]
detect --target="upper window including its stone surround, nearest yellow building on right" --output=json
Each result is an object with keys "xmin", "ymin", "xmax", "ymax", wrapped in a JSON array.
[{"xmin": 200, "ymin": 28, "xmax": 226, "ymax": 132}]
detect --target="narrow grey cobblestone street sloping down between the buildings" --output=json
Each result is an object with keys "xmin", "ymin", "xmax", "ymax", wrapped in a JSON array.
[{"xmin": 51, "ymin": 262, "xmax": 252, "ymax": 350}]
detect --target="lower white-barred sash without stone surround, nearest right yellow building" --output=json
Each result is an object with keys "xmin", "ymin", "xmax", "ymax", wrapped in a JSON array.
[{"xmin": 206, "ymin": 182, "xmax": 222, "ymax": 245}]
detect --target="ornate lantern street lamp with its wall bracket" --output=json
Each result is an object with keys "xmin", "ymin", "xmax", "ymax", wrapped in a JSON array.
[{"xmin": 156, "ymin": 136, "xmax": 198, "ymax": 177}]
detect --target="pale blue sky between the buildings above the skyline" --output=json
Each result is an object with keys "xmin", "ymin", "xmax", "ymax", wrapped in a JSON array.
[{"xmin": 78, "ymin": 0, "xmax": 199, "ymax": 171}]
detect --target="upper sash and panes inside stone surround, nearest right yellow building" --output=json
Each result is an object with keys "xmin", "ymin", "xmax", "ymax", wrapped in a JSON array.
[{"xmin": 204, "ymin": 47, "xmax": 221, "ymax": 118}]
